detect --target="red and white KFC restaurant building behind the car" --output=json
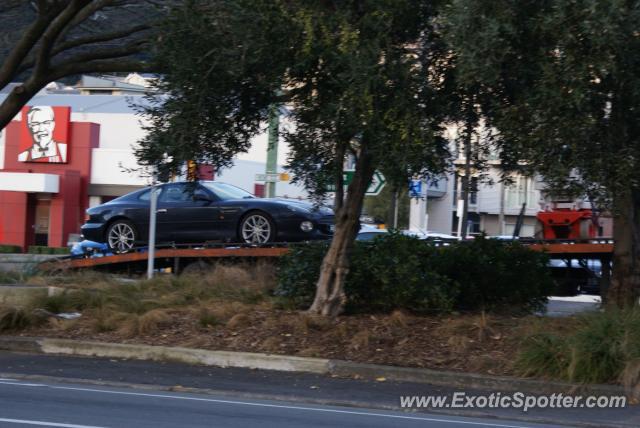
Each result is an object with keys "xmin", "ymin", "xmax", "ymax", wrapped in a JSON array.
[{"xmin": 0, "ymin": 75, "xmax": 304, "ymax": 249}]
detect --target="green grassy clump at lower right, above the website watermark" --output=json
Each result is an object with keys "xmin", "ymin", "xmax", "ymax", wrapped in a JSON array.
[{"xmin": 516, "ymin": 309, "xmax": 640, "ymax": 383}]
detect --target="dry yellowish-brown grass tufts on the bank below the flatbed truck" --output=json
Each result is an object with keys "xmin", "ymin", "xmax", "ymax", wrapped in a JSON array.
[{"xmin": 0, "ymin": 263, "xmax": 275, "ymax": 337}]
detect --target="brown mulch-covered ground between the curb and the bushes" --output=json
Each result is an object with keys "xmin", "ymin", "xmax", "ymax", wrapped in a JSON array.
[{"xmin": 20, "ymin": 304, "xmax": 552, "ymax": 375}]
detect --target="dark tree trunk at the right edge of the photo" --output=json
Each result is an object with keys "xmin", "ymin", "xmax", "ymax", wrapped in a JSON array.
[{"xmin": 608, "ymin": 190, "xmax": 640, "ymax": 308}]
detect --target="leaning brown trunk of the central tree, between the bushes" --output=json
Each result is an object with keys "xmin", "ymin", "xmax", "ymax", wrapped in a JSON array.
[{"xmin": 309, "ymin": 150, "xmax": 374, "ymax": 317}]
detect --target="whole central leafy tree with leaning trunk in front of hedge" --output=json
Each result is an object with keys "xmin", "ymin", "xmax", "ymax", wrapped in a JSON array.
[{"xmin": 139, "ymin": 0, "xmax": 448, "ymax": 316}]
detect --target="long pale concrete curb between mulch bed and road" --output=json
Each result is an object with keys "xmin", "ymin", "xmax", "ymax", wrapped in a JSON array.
[{"xmin": 0, "ymin": 336, "xmax": 627, "ymax": 395}]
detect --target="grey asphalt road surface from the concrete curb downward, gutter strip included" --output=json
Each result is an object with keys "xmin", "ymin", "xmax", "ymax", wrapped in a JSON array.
[{"xmin": 0, "ymin": 352, "xmax": 640, "ymax": 428}]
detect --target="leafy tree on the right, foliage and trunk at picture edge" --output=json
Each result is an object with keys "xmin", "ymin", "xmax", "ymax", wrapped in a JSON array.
[{"xmin": 447, "ymin": 0, "xmax": 640, "ymax": 307}]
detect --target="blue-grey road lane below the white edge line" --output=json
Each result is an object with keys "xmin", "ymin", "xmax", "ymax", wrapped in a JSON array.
[{"xmin": 0, "ymin": 378, "xmax": 551, "ymax": 428}]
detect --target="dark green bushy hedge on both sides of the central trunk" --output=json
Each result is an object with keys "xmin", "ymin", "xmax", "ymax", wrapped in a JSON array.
[{"xmin": 275, "ymin": 233, "xmax": 553, "ymax": 314}]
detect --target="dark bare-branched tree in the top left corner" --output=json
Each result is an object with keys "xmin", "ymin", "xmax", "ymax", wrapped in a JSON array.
[{"xmin": 0, "ymin": 0, "xmax": 171, "ymax": 129}]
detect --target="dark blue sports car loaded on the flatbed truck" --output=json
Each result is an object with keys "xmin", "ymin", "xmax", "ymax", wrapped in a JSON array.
[{"xmin": 82, "ymin": 181, "xmax": 334, "ymax": 253}]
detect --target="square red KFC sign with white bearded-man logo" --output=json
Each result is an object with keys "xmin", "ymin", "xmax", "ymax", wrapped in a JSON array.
[{"xmin": 18, "ymin": 106, "xmax": 71, "ymax": 163}]
